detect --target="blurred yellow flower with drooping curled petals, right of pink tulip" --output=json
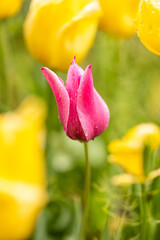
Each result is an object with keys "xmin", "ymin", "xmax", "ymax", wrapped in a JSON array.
[{"xmin": 108, "ymin": 123, "xmax": 160, "ymax": 183}]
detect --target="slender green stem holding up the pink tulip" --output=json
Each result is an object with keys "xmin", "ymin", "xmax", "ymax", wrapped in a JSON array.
[{"xmin": 81, "ymin": 142, "xmax": 90, "ymax": 240}]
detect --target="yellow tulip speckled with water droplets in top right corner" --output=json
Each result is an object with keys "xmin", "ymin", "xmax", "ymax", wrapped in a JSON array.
[{"xmin": 137, "ymin": 0, "xmax": 160, "ymax": 55}]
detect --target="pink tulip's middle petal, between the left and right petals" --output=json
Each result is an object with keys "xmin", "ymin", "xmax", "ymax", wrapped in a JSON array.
[{"xmin": 66, "ymin": 58, "xmax": 85, "ymax": 140}]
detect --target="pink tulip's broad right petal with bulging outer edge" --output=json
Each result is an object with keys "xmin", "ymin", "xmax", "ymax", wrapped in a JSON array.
[{"xmin": 77, "ymin": 65, "xmax": 109, "ymax": 141}]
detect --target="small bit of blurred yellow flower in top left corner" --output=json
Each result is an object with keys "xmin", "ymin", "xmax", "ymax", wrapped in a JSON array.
[{"xmin": 0, "ymin": 0, "xmax": 22, "ymax": 19}]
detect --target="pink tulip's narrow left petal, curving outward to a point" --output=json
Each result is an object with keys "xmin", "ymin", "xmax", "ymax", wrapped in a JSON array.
[{"xmin": 41, "ymin": 68, "xmax": 70, "ymax": 130}]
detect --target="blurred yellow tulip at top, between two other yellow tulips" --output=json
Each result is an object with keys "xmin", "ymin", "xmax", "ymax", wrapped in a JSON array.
[{"xmin": 100, "ymin": 0, "xmax": 140, "ymax": 38}]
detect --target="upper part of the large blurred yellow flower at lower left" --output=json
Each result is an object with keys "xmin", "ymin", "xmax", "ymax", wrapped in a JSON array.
[{"xmin": 0, "ymin": 96, "xmax": 45, "ymax": 185}]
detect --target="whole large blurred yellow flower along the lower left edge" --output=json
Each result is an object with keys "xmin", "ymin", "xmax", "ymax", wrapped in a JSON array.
[{"xmin": 0, "ymin": 97, "xmax": 46, "ymax": 240}]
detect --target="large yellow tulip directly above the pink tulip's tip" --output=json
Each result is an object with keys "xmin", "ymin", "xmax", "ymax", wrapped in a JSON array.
[{"xmin": 24, "ymin": 0, "xmax": 101, "ymax": 71}]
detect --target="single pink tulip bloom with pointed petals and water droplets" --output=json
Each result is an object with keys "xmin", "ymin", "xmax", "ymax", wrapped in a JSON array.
[{"xmin": 41, "ymin": 58, "xmax": 109, "ymax": 142}]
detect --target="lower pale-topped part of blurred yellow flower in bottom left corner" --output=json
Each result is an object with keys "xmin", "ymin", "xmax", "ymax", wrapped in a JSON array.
[{"xmin": 0, "ymin": 178, "xmax": 46, "ymax": 240}]
